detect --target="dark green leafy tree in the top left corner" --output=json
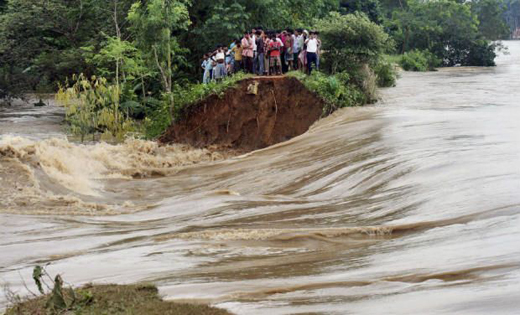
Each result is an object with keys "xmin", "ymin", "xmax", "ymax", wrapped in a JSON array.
[{"xmin": 0, "ymin": 0, "xmax": 129, "ymax": 90}]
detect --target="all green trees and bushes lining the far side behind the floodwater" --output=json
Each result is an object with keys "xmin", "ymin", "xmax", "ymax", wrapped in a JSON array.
[{"xmin": 0, "ymin": 0, "xmax": 520, "ymax": 140}]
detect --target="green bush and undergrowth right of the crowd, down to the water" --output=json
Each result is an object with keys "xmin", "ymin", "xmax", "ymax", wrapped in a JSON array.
[{"xmin": 289, "ymin": 12, "xmax": 396, "ymax": 115}]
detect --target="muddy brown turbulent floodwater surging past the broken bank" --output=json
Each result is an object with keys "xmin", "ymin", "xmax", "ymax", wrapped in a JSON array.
[{"xmin": 0, "ymin": 42, "xmax": 520, "ymax": 314}]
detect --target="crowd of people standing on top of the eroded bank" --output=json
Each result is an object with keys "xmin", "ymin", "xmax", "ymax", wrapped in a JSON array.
[{"xmin": 202, "ymin": 27, "xmax": 321, "ymax": 84}]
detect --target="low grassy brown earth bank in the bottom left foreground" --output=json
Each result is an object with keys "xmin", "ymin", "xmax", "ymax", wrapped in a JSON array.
[{"xmin": 4, "ymin": 285, "xmax": 231, "ymax": 315}]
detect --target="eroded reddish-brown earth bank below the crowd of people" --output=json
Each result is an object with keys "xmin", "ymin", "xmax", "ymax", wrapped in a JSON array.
[{"xmin": 159, "ymin": 77, "xmax": 323, "ymax": 151}]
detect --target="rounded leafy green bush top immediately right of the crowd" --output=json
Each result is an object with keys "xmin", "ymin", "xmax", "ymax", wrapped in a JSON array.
[{"xmin": 315, "ymin": 12, "xmax": 392, "ymax": 74}]
